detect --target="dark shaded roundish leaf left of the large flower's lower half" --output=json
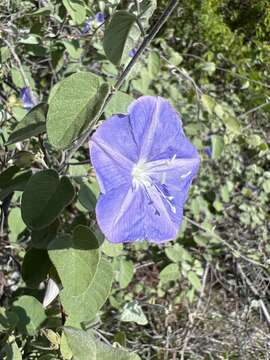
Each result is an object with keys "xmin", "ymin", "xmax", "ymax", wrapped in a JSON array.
[{"xmin": 21, "ymin": 170, "xmax": 75, "ymax": 229}]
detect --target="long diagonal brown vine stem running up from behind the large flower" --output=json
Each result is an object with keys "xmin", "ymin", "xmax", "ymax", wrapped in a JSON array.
[{"xmin": 60, "ymin": 0, "xmax": 179, "ymax": 171}]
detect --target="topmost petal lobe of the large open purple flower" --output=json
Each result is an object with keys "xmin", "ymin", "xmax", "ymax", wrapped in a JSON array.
[{"xmin": 128, "ymin": 96, "xmax": 184, "ymax": 161}]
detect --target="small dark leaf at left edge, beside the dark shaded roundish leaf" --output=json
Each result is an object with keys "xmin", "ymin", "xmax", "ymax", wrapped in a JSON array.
[{"xmin": 0, "ymin": 166, "xmax": 32, "ymax": 200}]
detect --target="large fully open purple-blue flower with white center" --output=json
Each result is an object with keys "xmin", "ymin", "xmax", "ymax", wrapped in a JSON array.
[{"xmin": 89, "ymin": 96, "xmax": 200, "ymax": 243}]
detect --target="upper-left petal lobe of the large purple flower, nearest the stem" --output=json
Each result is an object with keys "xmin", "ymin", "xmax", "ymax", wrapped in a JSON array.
[{"xmin": 89, "ymin": 115, "xmax": 138, "ymax": 193}]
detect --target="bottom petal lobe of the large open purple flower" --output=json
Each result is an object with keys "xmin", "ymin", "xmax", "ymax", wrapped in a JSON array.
[{"xmin": 96, "ymin": 186, "xmax": 182, "ymax": 243}]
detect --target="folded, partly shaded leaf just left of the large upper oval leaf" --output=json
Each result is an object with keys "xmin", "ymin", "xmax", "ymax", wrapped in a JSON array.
[{"xmin": 8, "ymin": 103, "xmax": 48, "ymax": 144}]
